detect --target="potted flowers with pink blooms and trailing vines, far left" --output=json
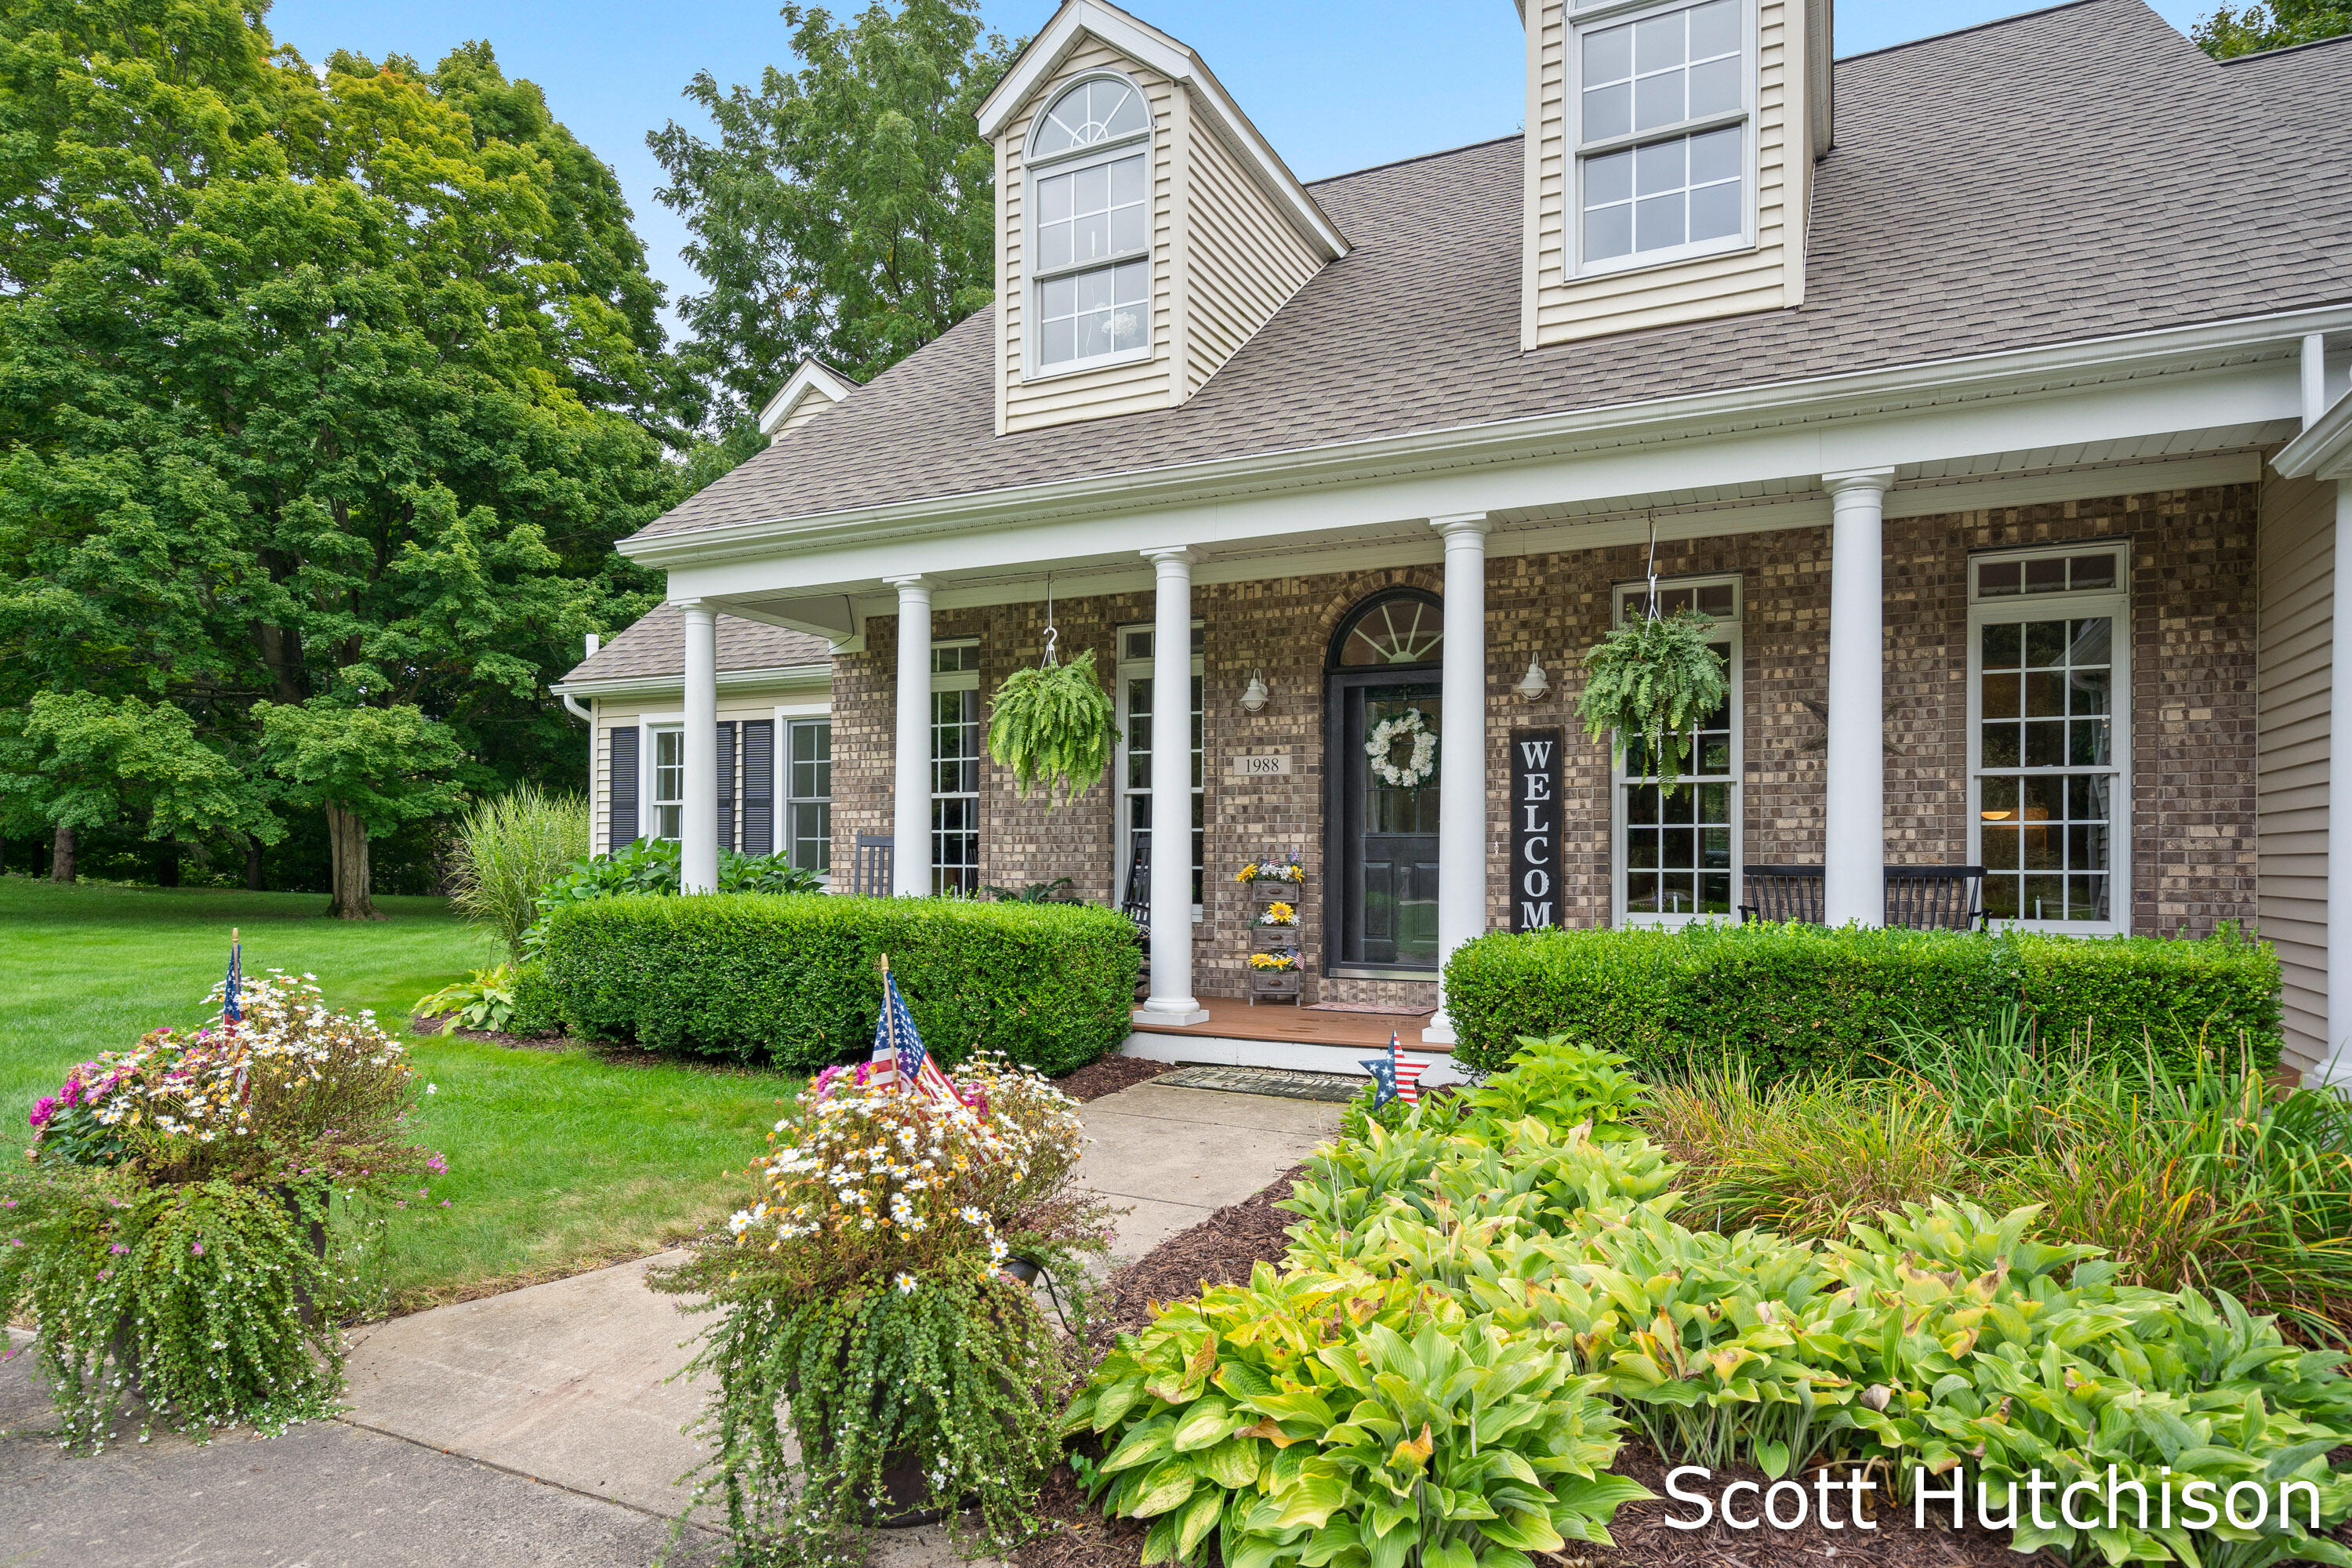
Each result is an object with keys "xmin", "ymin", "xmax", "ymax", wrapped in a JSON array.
[{"xmin": 0, "ymin": 971, "xmax": 447, "ymax": 1448}]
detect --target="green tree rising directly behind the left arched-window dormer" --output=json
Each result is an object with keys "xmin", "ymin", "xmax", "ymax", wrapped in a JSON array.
[{"xmin": 647, "ymin": 0, "xmax": 1014, "ymax": 421}]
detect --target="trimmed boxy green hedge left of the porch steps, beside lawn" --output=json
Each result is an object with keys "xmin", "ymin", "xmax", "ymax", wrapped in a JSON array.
[{"xmin": 543, "ymin": 893, "xmax": 1138, "ymax": 1074}]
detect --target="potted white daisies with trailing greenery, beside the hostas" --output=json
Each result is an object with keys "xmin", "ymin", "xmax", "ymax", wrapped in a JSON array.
[{"xmin": 652, "ymin": 1055, "xmax": 1110, "ymax": 1563}]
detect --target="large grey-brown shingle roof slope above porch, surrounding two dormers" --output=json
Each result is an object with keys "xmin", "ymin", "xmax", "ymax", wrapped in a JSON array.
[{"xmin": 626, "ymin": 0, "xmax": 2352, "ymax": 536}]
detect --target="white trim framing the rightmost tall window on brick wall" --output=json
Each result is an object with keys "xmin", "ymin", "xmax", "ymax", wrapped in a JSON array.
[{"xmin": 1966, "ymin": 539, "xmax": 2133, "ymax": 935}]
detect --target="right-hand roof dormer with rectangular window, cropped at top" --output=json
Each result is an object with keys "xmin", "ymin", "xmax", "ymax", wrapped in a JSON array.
[{"xmin": 1519, "ymin": 0, "xmax": 1830, "ymax": 348}]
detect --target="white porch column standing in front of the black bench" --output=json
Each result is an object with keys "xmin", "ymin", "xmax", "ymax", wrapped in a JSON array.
[{"xmin": 1820, "ymin": 468, "xmax": 1896, "ymax": 926}]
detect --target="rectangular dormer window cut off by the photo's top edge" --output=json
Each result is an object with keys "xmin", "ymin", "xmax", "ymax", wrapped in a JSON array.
[{"xmin": 1569, "ymin": 0, "xmax": 1755, "ymax": 273}]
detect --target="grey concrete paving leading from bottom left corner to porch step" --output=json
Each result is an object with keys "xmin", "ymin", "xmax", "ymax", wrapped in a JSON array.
[{"xmin": 0, "ymin": 1083, "xmax": 1338, "ymax": 1568}]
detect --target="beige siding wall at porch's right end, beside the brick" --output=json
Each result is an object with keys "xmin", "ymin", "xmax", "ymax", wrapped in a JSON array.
[{"xmin": 2256, "ymin": 480, "xmax": 2336, "ymax": 1072}]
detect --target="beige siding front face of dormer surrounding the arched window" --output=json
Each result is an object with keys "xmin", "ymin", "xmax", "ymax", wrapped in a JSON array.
[{"xmin": 997, "ymin": 38, "xmax": 1176, "ymax": 435}]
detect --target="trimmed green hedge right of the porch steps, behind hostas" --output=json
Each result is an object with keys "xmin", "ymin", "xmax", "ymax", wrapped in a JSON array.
[{"xmin": 1446, "ymin": 924, "xmax": 2279, "ymax": 1081}]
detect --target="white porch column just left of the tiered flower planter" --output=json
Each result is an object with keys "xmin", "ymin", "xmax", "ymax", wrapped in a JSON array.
[{"xmin": 1136, "ymin": 548, "xmax": 1209, "ymax": 1022}]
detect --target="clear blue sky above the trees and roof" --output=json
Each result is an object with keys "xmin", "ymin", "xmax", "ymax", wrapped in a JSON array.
[{"xmin": 268, "ymin": 0, "xmax": 2213, "ymax": 331}]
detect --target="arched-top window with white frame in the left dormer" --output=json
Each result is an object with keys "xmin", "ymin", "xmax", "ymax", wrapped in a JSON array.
[{"xmin": 1030, "ymin": 75, "xmax": 1152, "ymax": 372}]
